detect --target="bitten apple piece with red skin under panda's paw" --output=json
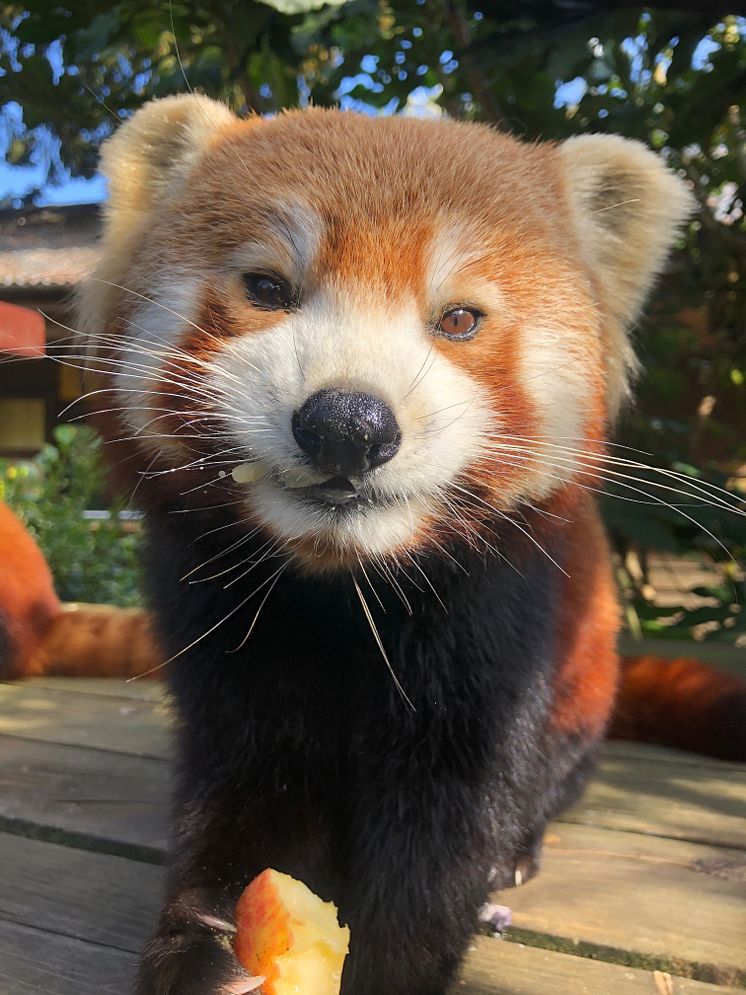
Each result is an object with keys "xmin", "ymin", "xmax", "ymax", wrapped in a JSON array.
[{"xmin": 235, "ymin": 868, "xmax": 350, "ymax": 995}]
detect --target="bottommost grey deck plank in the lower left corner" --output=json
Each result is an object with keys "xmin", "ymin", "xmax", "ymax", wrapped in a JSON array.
[{"xmin": 0, "ymin": 923, "xmax": 137, "ymax": 995}]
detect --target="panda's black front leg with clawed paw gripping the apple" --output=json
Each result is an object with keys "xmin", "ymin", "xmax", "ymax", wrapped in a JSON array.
[{"xmin": 136, "ymin": 752, "xmax": 334, "ymax": 995}]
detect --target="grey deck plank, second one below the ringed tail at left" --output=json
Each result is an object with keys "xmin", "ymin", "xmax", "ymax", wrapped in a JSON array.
[{"xmin": 0, "ymin": 736, "xmax": 170, "ymax": 860}]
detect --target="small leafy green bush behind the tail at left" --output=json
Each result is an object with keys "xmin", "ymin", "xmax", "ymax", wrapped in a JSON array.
[{"xmin": 0, "ymin": 425, "xmax": 140, "ymax": 605}]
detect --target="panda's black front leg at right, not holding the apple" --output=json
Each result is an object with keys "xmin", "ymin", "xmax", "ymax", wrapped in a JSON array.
[{"xmin": 341, "ymin": 677, "xmax": 540, "ymax": 995}]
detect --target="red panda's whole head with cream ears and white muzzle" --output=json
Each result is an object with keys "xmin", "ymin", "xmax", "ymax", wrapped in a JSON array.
[{"xmin": 78, "ymin": 98, "xmax": 686, "ymax": 569}]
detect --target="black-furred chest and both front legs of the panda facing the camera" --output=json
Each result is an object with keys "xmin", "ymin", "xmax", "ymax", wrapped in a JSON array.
[{"xmin": 140, "ymin": 516, "xmax": 564, "ymax": 995}]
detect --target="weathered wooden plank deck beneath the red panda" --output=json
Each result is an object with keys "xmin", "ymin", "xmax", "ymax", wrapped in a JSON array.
[{"xmin": 0, "ymin": 644, "xmax": 746, "ymax": 995}]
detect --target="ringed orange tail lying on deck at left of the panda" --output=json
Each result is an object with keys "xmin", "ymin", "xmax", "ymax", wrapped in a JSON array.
[{"xmin": 36, "ymin": 604, "xmax": 164, "ymax": 677}]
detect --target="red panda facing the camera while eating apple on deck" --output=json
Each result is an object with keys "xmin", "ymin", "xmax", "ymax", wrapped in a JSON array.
[{"xmin": 20, "ymin": 96, "xmax": 744, "ymax": 995}]
